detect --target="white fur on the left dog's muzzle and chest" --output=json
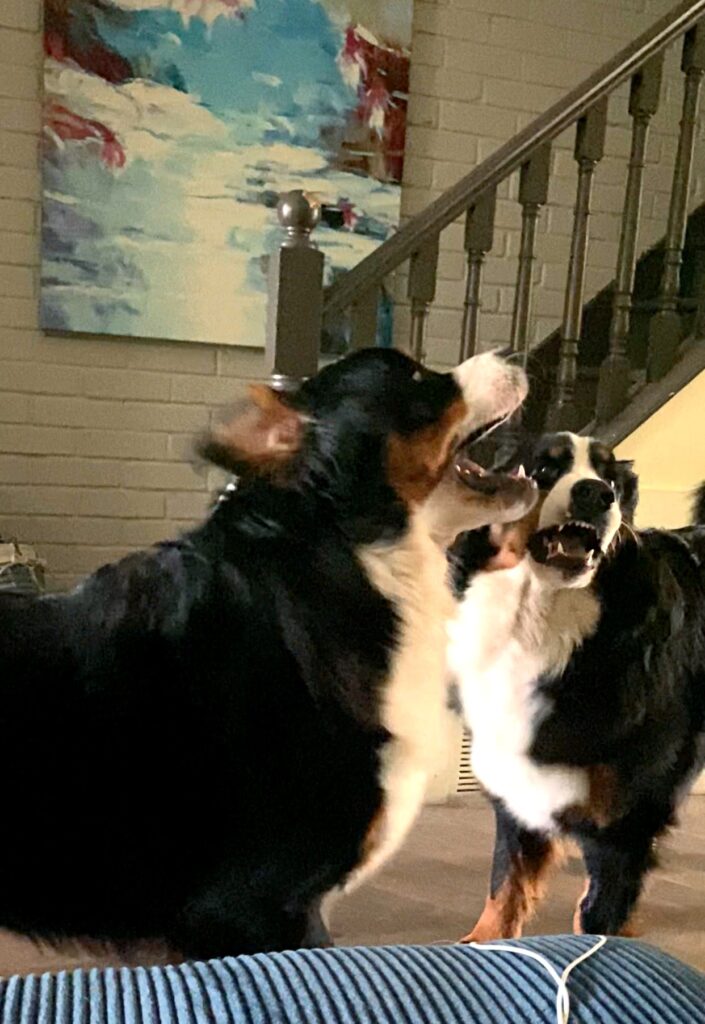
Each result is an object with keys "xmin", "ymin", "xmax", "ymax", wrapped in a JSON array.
[{"xmin": 345, "ymin": 353, "xmax": 527, "ymax": 890}]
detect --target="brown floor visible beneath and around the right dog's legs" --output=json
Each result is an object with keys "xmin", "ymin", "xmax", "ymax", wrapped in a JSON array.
[{"xmin": 333, "ymin": 794, "xmax": 705, "ymax": 971}]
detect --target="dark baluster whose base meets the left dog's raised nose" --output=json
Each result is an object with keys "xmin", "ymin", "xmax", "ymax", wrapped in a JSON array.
[{"xmin": 511, "ymin": 143, "xmax": 551, "ymax": 367}]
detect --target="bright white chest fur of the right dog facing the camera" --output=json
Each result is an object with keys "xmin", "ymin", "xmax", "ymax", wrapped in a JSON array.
[{"xmin": 449, "ymin": 559, "xmax": 598, "ymax": 831}]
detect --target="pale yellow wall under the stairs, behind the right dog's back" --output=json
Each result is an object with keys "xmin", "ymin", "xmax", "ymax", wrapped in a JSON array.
[{"xmin": 617, "ymin": 373, "xmax": 705, "ymax": 526}]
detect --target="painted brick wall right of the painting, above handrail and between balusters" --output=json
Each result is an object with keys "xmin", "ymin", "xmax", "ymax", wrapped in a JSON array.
[{"xmin": 396, "ymin": 0, "xmax": 705, "ymax": 364}]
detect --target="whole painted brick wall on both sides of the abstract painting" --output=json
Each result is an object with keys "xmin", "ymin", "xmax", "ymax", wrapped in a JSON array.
[{"xmin": 0, "ymin": 0, "xmax": 703, "ymax": 587}]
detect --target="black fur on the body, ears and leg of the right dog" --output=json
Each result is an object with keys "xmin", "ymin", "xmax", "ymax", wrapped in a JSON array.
[{"xmin": 455, "ymin": 435, "xmax": 705, "ymax": 934}]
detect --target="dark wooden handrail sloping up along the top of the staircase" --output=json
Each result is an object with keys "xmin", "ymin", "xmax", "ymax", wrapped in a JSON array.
[{"xmin": 324, "ymin": 0, "xmax": 705, "ymax": 315}]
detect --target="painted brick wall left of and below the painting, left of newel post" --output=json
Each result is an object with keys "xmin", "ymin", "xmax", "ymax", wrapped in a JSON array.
[{"xmin": 0, "ymin": 0, "xmax": 261, "ymax": 587}]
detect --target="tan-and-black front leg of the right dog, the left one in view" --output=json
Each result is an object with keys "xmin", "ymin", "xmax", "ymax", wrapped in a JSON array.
[{"xmin": 462, "ymin": 801, "xmax": 555, "ymax": 942}]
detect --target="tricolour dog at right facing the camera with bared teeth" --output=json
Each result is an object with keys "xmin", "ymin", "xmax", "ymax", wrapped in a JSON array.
[{"xmin": 450, "ymin": 433, "xmax": 705, "ymax": 941}]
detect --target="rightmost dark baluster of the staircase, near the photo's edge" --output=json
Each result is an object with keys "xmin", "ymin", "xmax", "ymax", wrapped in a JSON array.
[{"xmin": 647, "ymin": 22, "xmax": 705, "ymax": 381}]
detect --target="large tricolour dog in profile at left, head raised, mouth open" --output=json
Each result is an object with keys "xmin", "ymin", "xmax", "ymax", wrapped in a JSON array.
[{"xmin": 0, "ymin": 350, "xmax": 535, "ymax": 957}]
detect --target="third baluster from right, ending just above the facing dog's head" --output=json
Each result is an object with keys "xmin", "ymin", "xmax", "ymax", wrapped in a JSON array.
[{"xmin": 546, "ymin": 98, "xmax": 608, "ymax": 430}]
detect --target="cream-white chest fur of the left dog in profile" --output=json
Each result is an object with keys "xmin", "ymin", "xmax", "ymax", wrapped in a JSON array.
[{"xmin": 345, "ymin": 517, "xmax": 453, "ymax": 889}]
